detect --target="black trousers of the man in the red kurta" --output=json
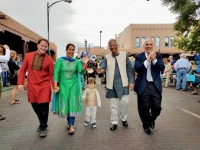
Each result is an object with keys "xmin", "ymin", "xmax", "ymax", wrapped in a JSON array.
[{"xmin": 31, "ymin": 103, "xmax": 49, "ymax": 129}]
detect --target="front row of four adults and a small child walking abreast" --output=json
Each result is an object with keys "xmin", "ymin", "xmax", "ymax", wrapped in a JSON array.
[{"xmin": 0, "ymin": 38, "xmax": 165, "ymax": 137}]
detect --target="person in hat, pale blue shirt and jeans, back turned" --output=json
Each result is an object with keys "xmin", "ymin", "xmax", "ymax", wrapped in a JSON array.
[{"xmin": 174, "ymin": 53, "xmax": 190, "ymax": 91}]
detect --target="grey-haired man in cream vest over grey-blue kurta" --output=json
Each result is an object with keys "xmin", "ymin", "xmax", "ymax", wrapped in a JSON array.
[{"xmin": 97, "ymin": 39, "xmax": 134, "ymax": 131}]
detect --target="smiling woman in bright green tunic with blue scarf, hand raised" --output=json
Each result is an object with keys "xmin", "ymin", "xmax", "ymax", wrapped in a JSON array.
[{"xmin": 52, "ymin": 43, "xmax": 88, "ymax": 133}]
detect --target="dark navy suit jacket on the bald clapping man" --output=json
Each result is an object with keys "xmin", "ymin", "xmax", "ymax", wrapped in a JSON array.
[{"xmin": 134, "ymin": 52, "xmax": 165, "ymax": 94}]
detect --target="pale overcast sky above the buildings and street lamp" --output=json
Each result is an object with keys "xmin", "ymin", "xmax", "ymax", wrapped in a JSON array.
[{"xmin": 0, "ymin": 0, "xmax": 176, "ymax": 56}]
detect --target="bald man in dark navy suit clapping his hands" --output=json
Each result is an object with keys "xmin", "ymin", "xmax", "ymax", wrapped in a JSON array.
[{"xmin": 134, "ymin": 38, "xmax": 165, "ymax": 134}]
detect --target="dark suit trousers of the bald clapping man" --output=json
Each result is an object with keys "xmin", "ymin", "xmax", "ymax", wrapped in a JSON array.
[{"xmin": 137, "ymin": 82, "xmax": 162, "ymax": 127}]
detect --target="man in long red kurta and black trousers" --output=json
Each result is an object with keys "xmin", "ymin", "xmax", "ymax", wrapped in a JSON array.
[{"xmin": 18, "ymin": 39, "xmax": 54, "ymax": 137}]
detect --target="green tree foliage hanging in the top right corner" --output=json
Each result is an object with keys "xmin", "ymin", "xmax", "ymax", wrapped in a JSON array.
[{"xmin": 161, "ymin": 0, "xmax": 200, "ymax": 52}]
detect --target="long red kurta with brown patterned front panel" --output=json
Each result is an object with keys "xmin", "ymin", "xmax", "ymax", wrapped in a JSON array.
[{"xmin": 18, "ymin": 52, "xmax": 54, "ymax": 103}]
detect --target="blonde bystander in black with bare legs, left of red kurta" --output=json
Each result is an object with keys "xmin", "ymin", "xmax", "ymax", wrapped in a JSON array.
[{"xmin": 8, "ymin": 50, "xmax": 20, "ymax": 105}]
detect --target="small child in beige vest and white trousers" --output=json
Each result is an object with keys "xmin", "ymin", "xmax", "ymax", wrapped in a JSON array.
[{"xmin": 83, "ymin": 77, "xmax": 101, "ymax": 128}]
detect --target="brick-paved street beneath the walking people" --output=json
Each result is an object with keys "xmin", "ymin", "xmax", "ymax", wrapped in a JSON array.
[{"xmin": 0, "ymin": 84, "xmax": 200, "ymax": 150}]
